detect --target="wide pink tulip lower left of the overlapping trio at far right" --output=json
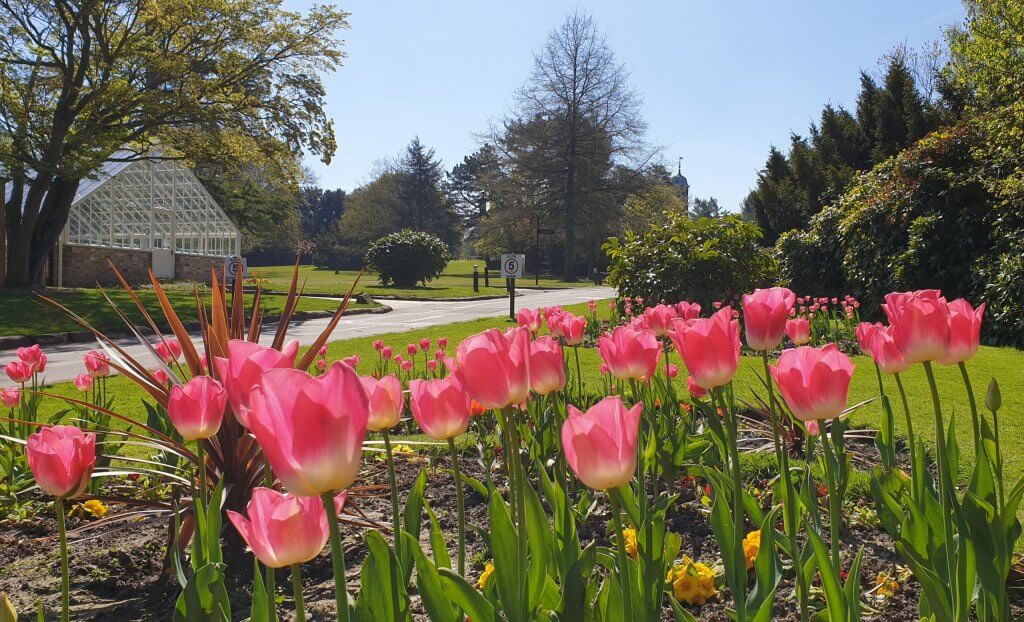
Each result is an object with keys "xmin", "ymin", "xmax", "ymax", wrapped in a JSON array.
[{"xmin": 770, "ymin": 343, "xmax": 853, "ymax": 421}]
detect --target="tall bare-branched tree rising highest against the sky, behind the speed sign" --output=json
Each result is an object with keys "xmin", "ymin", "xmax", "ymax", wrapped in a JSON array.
[{"xmin": 514, "ymin": 11, "xmax": 654, "ymax": 281}]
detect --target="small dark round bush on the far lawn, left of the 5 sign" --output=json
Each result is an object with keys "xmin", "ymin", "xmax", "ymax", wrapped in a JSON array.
[{"xmin": 366, "ymin": 229, "xmax": 452, "ymax": 287}]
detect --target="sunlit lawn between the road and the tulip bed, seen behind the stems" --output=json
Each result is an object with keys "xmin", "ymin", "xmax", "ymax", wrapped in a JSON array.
[{"xmin": 32, "ymin": 304, "xmax": 1024, "ymax": 493}]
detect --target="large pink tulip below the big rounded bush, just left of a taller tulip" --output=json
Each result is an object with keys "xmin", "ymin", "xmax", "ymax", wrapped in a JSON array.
[{"xmin": 669, "ymin": 306, "xmax": 739, "ymax": 389}]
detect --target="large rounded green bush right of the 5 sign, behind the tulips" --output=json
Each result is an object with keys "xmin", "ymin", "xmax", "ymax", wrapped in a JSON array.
[{"xmin": 604, "ymin": 216, "xmax": 778, "ymax": 308}]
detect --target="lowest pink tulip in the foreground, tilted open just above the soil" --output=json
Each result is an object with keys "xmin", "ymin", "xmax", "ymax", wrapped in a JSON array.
[{"xmin": 227, "ymin": 488, "xmax": 330, "ymax": 568}]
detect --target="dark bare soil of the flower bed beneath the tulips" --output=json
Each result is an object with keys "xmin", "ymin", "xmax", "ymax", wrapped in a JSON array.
[{"xmin": 0, "ymin": 451, "xmax": 1024, "ymax": 622}]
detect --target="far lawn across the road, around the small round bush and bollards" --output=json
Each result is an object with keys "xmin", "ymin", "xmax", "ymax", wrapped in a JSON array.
[{"xmin": 249, "ymin": 259, "xmax": 590, "ymax": 298}]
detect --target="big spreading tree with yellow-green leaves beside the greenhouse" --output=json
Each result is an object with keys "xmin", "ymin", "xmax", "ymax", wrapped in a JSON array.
[{"xmin": 0, "ymin": 0, "xmax": 346, "ymax": 286}]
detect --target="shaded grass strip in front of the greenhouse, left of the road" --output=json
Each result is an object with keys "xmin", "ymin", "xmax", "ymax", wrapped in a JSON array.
[{"xmin": 0, "ymin": 286, "xmax": 366, "ymax": 336}]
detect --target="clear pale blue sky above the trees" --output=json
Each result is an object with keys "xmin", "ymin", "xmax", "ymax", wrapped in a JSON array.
[{"xmin": 285, "ymin": 0, "xmax": 964, "ymax": 210}]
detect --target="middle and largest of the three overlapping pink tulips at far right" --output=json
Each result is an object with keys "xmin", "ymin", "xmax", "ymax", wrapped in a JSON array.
[{"xmin": 882, "ymin": 289, "xmax": 949, "ymax": 365}]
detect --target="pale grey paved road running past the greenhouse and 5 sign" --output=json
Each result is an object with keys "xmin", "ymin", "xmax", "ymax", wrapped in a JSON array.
[{"xmin": 0, "ymin": 287, "xmax": 614, "ymax": 387}]
